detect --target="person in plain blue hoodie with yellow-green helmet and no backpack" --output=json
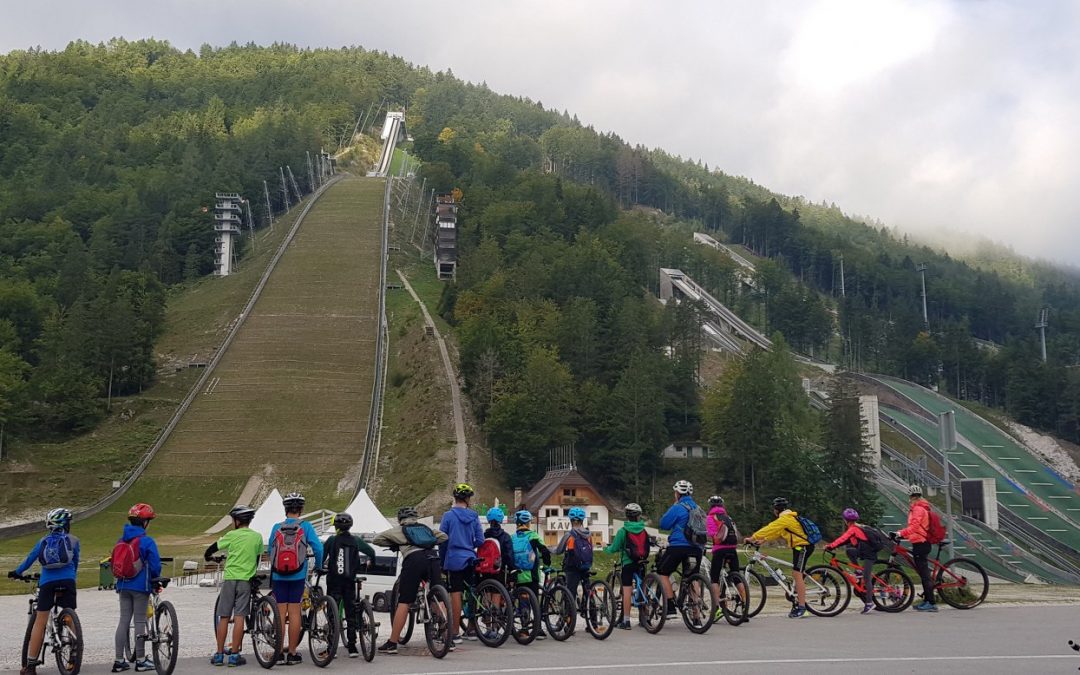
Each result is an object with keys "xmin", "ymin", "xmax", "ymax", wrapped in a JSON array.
[{"xmin": 438, "ymin": 483, "xmax": 484, "ymax": 644}]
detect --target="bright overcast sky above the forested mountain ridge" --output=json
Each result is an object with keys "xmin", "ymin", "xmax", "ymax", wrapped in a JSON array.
[{"xmin": 0, "ymin": 0, "xmax": 1080, "ymax": 264}]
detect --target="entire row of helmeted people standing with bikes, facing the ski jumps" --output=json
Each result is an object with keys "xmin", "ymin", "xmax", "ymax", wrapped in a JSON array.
[{"xmin": 9, "ymin": 481, "xmax": 940, "ymax": 675}]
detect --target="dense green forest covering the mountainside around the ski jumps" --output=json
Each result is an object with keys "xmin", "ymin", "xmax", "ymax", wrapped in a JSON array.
[{"xmin": 0, "ymin": 40, "xmax": 1080, "ymax": 520}]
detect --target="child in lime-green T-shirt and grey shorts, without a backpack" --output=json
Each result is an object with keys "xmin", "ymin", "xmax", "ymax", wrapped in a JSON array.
[{"xmin": 203, "ymin": 504, "xmax": 262, "ymax": 666}]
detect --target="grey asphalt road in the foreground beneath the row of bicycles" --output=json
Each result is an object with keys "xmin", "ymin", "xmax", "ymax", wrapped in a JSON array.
[{"xmin": 0, "ymin": 604, "xmax": 1080, "ymax": 675}]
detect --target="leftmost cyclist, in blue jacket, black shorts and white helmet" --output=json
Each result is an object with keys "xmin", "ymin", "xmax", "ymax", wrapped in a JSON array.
[{"xmin": 8, "ymin": 509, "xmax": 79, "ymax": 675}]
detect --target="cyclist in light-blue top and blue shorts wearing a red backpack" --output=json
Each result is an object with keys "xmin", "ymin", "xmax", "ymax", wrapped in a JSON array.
[{"xmin": 267, "ymin": 492, "xmax": 323, "ymax": 665}]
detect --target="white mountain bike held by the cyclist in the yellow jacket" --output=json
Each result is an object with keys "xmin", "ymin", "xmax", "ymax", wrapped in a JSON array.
[{"xmin": 743, "ymin": 544, "xmax": 847, "ymax": 619}]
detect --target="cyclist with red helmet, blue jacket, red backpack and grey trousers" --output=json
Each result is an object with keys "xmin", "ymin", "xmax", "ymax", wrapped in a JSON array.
[{"xmin": 112, "ymin": 503, "xmax": 161, "ymax": 673}]
